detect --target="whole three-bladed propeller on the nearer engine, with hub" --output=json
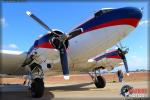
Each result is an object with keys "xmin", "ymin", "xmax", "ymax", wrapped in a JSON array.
[{"xmin": 26, "ymin": 11, "xmax": 83, "ymax": 80}]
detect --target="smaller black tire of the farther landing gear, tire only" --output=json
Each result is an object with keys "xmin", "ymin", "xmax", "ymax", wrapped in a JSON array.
[{"xmin": 94, "ymin": 76, "xmax": 106, "ymax": 88}]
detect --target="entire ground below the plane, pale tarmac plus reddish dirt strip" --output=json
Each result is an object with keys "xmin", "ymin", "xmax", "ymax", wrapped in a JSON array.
[{"xmin": 0, "ymin": 72, "xmax": 150, "ymax": 100}]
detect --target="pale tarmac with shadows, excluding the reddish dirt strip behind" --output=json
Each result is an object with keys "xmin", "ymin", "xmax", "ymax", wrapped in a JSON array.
[{"xmin": 0, "ymin": 81, "xmax": 149, "ymax": 100}]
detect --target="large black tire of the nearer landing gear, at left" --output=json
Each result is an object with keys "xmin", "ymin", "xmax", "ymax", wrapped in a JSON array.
[{"xmin": 31, "ymin": 78, "xmax": 44, "ymax": 98}]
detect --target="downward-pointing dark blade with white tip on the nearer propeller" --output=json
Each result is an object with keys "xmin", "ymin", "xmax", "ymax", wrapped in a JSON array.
[{"xmin": 60, "ymin": 47, "xmax": 69, "ymax": 80}]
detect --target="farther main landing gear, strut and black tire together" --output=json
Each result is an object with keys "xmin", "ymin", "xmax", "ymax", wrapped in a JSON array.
[{"xmin": 89, "ymin": 67, "xmax": 106, "ymax": 88}]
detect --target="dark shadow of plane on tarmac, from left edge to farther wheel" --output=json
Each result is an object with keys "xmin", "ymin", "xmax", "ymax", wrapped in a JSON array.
[{"xmin": 0, "ymin": 82, "xmax": 93, "ymax": 100}]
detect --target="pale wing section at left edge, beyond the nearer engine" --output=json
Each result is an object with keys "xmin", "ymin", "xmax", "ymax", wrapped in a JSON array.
[{"xmin": 0, "ymin": 50, "xmax": 27, "ymax": 75}]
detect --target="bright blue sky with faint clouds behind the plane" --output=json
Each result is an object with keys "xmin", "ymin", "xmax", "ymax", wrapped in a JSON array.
[{"xmin": 0, "ymin": 2, "xmax": 150, "ymax": 70}]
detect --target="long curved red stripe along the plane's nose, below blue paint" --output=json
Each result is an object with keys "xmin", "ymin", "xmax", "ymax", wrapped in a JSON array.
[{"xmin": 83, "ymin": 18, "xmax": 140, "ymax": 33}]
